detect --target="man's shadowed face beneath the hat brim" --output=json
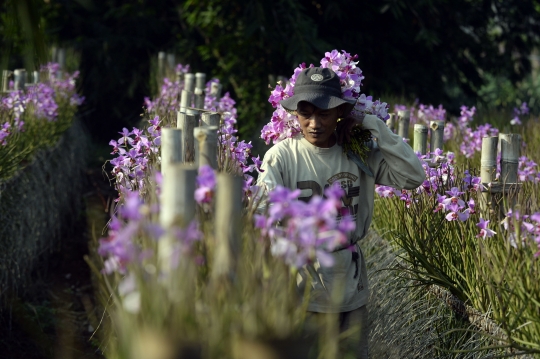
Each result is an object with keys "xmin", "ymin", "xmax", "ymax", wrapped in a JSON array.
[{"xmin": 296, "ymin": 101, "xmax": 341, "ymax": 148}]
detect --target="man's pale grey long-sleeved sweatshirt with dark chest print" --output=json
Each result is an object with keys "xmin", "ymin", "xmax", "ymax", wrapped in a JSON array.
[{"xmin": 257, "ymin": 115, "xmax": 425, "ymax": 313}]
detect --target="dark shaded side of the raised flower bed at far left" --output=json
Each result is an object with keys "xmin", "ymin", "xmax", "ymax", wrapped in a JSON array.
[{"xmin": 0, "ymin": 120, "xmax": 88, "ymax": 300}]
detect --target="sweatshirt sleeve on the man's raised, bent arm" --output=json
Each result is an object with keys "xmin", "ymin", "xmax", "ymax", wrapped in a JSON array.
[{"xmin": 362, "ymin": 115, "xmax": 426, "ymax": 189}]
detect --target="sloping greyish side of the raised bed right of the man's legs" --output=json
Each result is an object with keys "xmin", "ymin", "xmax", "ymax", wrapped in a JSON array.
[{"xmin": 362, "ymin": 230, "xmax": 504, "ymax": 359}]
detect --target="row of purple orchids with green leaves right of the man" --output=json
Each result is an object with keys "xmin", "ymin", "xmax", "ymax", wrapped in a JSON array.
[{"xmin": 374, "ymin": 104, "xmax": 540, "ymax": 353}]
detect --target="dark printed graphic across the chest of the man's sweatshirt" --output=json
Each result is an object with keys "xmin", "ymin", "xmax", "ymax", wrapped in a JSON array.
[{"xmin": 296, "ymin": 172, "xmax": 360, "ymax": 220}]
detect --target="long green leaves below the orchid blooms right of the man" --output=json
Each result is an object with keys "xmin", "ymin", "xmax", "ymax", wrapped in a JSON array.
[{"xmin": 374, "ymin": 186, "xmax": 540, "ymax": 358}]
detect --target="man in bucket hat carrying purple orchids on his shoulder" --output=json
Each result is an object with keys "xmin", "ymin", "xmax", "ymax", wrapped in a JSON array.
[{"xmin": 257, "ymin": 67, "xmax": 425, "ymax": 358}]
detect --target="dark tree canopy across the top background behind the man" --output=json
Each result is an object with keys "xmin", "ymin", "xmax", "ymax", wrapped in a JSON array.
[{"xmin": 3, "ymin": 0, "xmax": 540, "ymax": 140}]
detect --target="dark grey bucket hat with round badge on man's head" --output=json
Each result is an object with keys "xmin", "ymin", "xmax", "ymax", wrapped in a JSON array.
[{"xmin": 280, "ymin": 67, "xmax": 356, "ymax": 116}]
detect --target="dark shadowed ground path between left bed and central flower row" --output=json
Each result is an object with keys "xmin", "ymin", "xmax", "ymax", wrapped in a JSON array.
[{"xmin": 0, "ymin": 146, "xmax": 115, "ymax": 359}]
